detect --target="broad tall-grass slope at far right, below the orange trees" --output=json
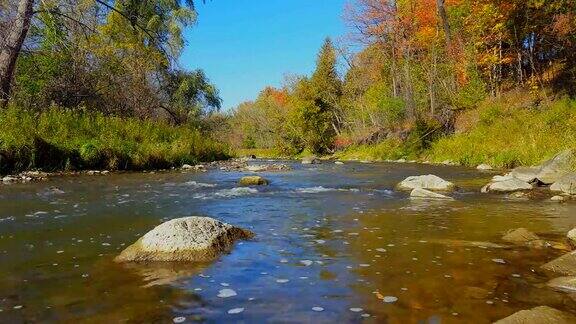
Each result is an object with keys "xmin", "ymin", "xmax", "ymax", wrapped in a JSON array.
[{"xmin": 425, "ymin": 99, "xmax": 576, "ymax": 168}]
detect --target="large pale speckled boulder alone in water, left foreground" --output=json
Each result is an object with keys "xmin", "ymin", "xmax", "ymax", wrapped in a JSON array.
[{"xmin": 114, "ymin": 216, "xmax": 254, "ymax": 262}]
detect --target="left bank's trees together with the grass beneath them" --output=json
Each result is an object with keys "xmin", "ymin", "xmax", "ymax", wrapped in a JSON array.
[{"xmin": 0, "ymin": 0, "xmax": 226, "ymax": 173}]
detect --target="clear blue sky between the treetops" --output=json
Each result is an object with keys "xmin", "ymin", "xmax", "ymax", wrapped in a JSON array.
[{"xmin": 180, "ymin": 0, "xmax": 346, "ymax": 110}]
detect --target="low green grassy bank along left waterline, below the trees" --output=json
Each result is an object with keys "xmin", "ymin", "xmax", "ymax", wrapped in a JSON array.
[{"xmin": 0, "ymin": 107, "xmax": 228, "ymax": 174}]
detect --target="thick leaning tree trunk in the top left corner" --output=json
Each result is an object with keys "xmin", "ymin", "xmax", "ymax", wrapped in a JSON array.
[{"xmin": 0, "ymin": 0, "xmax": 34, "ymax": 105}]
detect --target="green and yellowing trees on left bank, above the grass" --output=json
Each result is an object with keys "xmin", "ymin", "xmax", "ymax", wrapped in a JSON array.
[{"xmin": 0, "ymin": 0, "xmax": 221, "ymax": 123}]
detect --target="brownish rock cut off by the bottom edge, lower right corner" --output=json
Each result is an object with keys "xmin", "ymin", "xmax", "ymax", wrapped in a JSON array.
[{"xmin": 495, "ymin": 306, "xmax": 576, "ymax": 324}]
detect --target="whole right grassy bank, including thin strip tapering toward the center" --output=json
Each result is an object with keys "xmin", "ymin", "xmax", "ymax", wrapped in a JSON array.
[{"xmin": 336, "ymin": 94, "xmax": 576, "ymax": 167}]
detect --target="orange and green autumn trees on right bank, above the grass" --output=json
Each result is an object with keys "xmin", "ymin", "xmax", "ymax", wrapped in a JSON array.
[{"xmin": 225, "ymin": 0, "xmax": 576, "ymax": 154}]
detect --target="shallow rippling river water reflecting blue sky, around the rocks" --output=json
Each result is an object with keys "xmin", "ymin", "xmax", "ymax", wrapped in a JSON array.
[{"xmin": 0, "ymin": 162, "xmax": 576, "ymax": 323}]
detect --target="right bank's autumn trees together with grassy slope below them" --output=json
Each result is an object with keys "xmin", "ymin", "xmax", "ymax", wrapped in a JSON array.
[{"xmin": 228, "ymin": 0, "xmax": 576, "ymax": 167}]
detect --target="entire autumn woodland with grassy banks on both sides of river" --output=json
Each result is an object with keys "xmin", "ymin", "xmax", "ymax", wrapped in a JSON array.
[{"xmin": 0, "ymin": 0, "xmax": 576, "ymax": 172}]
